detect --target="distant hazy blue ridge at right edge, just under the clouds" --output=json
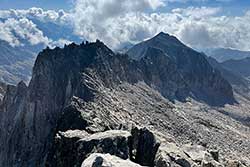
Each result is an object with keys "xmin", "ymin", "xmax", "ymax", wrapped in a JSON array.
[{"xmin": 206, "ymin": 48, "xmax": 250, "ymax": 63}]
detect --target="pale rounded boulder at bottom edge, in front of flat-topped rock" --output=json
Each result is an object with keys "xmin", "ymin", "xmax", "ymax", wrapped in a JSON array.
[{"xmin": 81, "ymin": 153, "xmax": 141, "ymax": 167}]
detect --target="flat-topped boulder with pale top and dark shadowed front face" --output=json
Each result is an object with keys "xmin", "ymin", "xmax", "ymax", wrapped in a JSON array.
[{"xmin": 47, "ymin": 130, "xmax": 131, "ymax": 167}]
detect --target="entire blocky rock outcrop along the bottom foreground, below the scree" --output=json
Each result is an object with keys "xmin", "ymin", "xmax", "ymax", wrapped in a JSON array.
[{"xmin": 46, "ymin": 127, "xmax": 244, "ymax": 167}]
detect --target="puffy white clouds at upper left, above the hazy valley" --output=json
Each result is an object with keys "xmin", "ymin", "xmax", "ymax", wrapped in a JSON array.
[{"xmin": 0, "ymin": 8, "xmax": 70, "ymax": 47}]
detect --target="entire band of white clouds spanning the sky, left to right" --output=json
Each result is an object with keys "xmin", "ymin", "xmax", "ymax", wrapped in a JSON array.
[{"xmin": 0, "ymin": 0, "xmax": 250, "ymax": 50}]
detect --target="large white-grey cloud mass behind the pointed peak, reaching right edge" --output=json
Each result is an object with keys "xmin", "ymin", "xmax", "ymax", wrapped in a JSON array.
[{"xmin": 72, "ymin": 0, "xmax": 250, "ymax": 50}]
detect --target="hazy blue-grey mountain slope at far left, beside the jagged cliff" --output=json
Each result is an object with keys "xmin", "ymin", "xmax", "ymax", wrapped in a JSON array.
[{"xmin": 0, "ymin": 41, "xmax": 35, "ymax": 84}]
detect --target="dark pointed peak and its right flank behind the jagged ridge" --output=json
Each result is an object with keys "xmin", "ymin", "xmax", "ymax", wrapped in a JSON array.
[{"xmin": 127, "ymin": 32, "xmax": 234, "ymax": 105}]
